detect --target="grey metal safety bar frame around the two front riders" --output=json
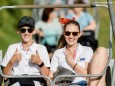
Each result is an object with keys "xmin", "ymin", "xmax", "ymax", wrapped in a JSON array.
[{"xmin": 0, "ymin": 4, "xmax": 113, "ymax": 86}]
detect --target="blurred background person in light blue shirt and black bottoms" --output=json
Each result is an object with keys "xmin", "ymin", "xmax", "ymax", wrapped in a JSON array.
[{"xmin": 66, "ymin": 0, "xmax": 98, "ymax": 51}]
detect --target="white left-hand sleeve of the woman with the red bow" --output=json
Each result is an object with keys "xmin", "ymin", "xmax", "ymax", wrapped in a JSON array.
[{"xmin": 50, "ymin": 52, "xmax": 58, "ymax": 73}]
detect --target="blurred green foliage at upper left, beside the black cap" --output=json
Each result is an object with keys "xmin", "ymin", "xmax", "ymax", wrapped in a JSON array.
[{"xmin": 0, "ymin": 0, "xmax": 33, "ymax": 53}]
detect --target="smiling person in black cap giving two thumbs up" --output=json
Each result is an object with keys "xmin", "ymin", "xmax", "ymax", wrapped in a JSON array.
[{"xmin": 1, "ymin": 16, "xmax": 50, "ymax": 86}]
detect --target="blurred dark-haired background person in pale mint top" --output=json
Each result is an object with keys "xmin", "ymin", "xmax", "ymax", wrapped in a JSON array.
[{"xmin": 35, "ymin": 8, "xmax": 63, "ymax": 57}]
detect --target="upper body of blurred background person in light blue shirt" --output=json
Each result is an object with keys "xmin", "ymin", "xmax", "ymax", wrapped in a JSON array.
[{"xmin": 66, "ymin": 0, "xmax": 96, "ymax": 31}]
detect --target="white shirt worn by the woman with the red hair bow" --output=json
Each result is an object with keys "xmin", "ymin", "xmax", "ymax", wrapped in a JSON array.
[{"xmin": 50, "ymin": 44, "xmax": 93, "ymax": 83}]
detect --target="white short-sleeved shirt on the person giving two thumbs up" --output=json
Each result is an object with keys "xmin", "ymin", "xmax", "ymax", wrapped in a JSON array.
[{"xmin": 1, "ymin": 42, "xmax": 50, "ymax": 75}]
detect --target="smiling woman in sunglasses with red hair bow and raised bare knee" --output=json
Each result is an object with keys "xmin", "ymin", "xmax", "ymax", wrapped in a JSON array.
[{"xmin": 49, "ymin": 18, "xmax": 107, "ymax": 86}]
